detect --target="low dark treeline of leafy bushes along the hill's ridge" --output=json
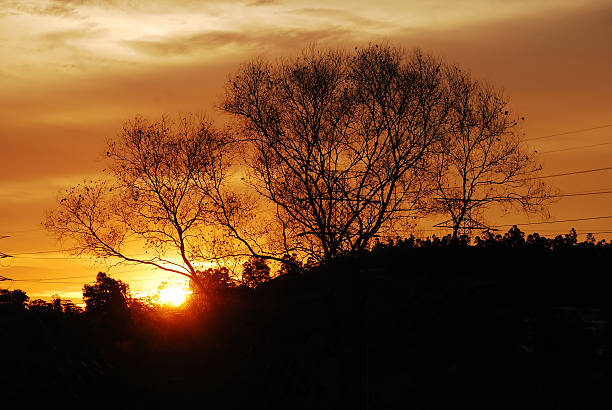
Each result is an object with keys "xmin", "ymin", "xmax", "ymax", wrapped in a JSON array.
[{"xmin": 0, "ymin": 225, "xmax": 612, "ymax": 314}]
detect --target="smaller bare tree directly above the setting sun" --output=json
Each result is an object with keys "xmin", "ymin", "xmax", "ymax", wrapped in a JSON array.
[{"xmin": 43, "ymin": 115, "xmax": 232, "ymax": 294}]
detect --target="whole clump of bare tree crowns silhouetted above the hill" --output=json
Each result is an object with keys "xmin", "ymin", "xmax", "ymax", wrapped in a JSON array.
[{"xmin": 44, "ymin": 44, "xmax": 550, "ymax": 286}]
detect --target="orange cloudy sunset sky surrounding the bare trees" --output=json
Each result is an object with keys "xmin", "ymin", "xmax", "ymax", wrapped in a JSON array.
[{"xmin": 0, "ymin": 0, "xmax": 612, "ymax": 300}]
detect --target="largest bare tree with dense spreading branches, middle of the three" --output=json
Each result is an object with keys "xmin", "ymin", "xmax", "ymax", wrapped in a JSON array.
[{"xmin": 223, "ymin": 45, "xmax": 450, "ymax": 260}]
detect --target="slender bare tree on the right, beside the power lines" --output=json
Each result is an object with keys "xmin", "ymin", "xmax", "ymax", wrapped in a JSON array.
[{"xmin": 435, "ymin": 67, "xmax": 551, "ymax": 238}]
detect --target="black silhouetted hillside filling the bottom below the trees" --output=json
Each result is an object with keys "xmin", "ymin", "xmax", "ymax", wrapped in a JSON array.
[{"xmin": 0, "ymin": 227, "xmax": 612, "ymax": 409}]
